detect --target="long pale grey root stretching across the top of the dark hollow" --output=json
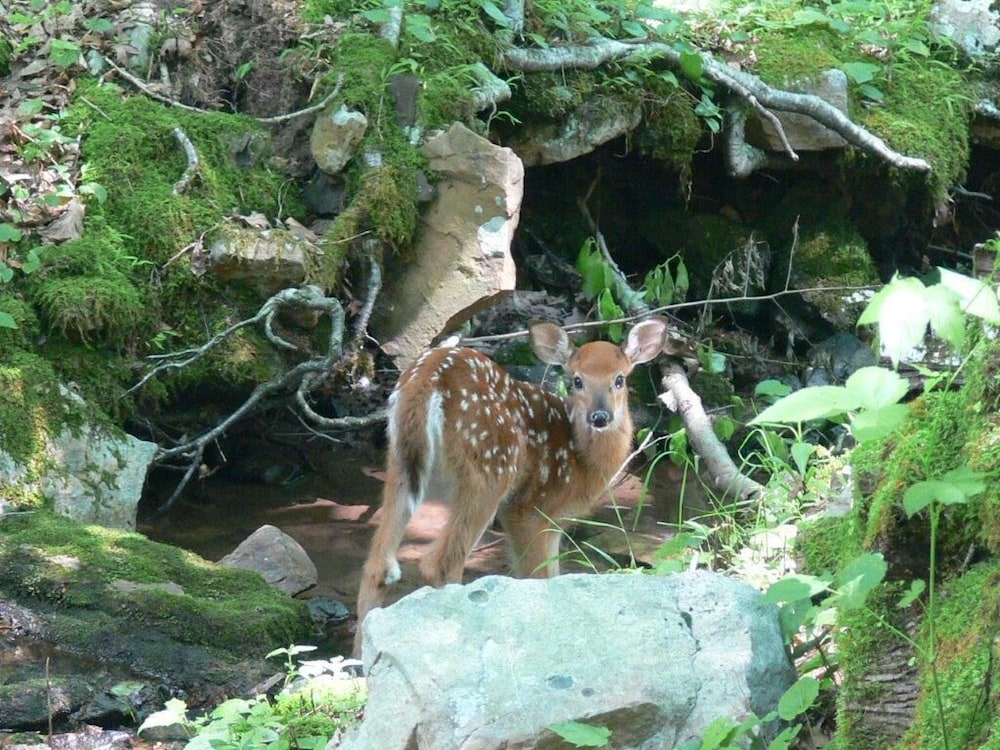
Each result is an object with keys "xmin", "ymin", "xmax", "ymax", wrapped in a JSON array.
[{"xmin": 503, "ymin": 37, "xmax": 931, "ymax": 172}]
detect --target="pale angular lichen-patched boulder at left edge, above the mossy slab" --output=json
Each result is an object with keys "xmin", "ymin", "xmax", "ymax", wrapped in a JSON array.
[{"xmin": 0, "ymin": 387, "xmax": 157, "ymax": 531}]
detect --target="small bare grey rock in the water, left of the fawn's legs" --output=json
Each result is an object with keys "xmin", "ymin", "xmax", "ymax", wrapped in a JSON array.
[{"xmin": 219, "ymin": 525, "xmax": 317, "ymax": 596}]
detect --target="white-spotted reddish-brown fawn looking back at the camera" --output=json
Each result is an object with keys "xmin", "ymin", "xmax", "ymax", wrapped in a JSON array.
[{"xmin": 354, "ymin": 318, "xmax": 667, "ymax": 654}]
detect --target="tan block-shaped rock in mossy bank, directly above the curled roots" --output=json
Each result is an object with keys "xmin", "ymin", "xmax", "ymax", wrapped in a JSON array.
[{"xmin": 201, "ymin": 224, "xmax": 316, "ymax": 296}]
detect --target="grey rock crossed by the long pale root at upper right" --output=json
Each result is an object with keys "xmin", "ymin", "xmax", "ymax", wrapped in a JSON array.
[{"xmin": 747, "ymin": 69, "xmax": 848, "ymax": 151}]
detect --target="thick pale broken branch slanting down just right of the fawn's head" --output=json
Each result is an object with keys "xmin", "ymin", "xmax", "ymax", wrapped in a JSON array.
[{"xmin": 660, "ymin": 365, "xmax": 764, "ymax": 500}]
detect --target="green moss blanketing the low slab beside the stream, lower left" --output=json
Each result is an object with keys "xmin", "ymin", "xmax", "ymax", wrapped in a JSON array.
[{"xmin": 0, "ymin": 512, "xmax": 309, "ymax": 657}]
